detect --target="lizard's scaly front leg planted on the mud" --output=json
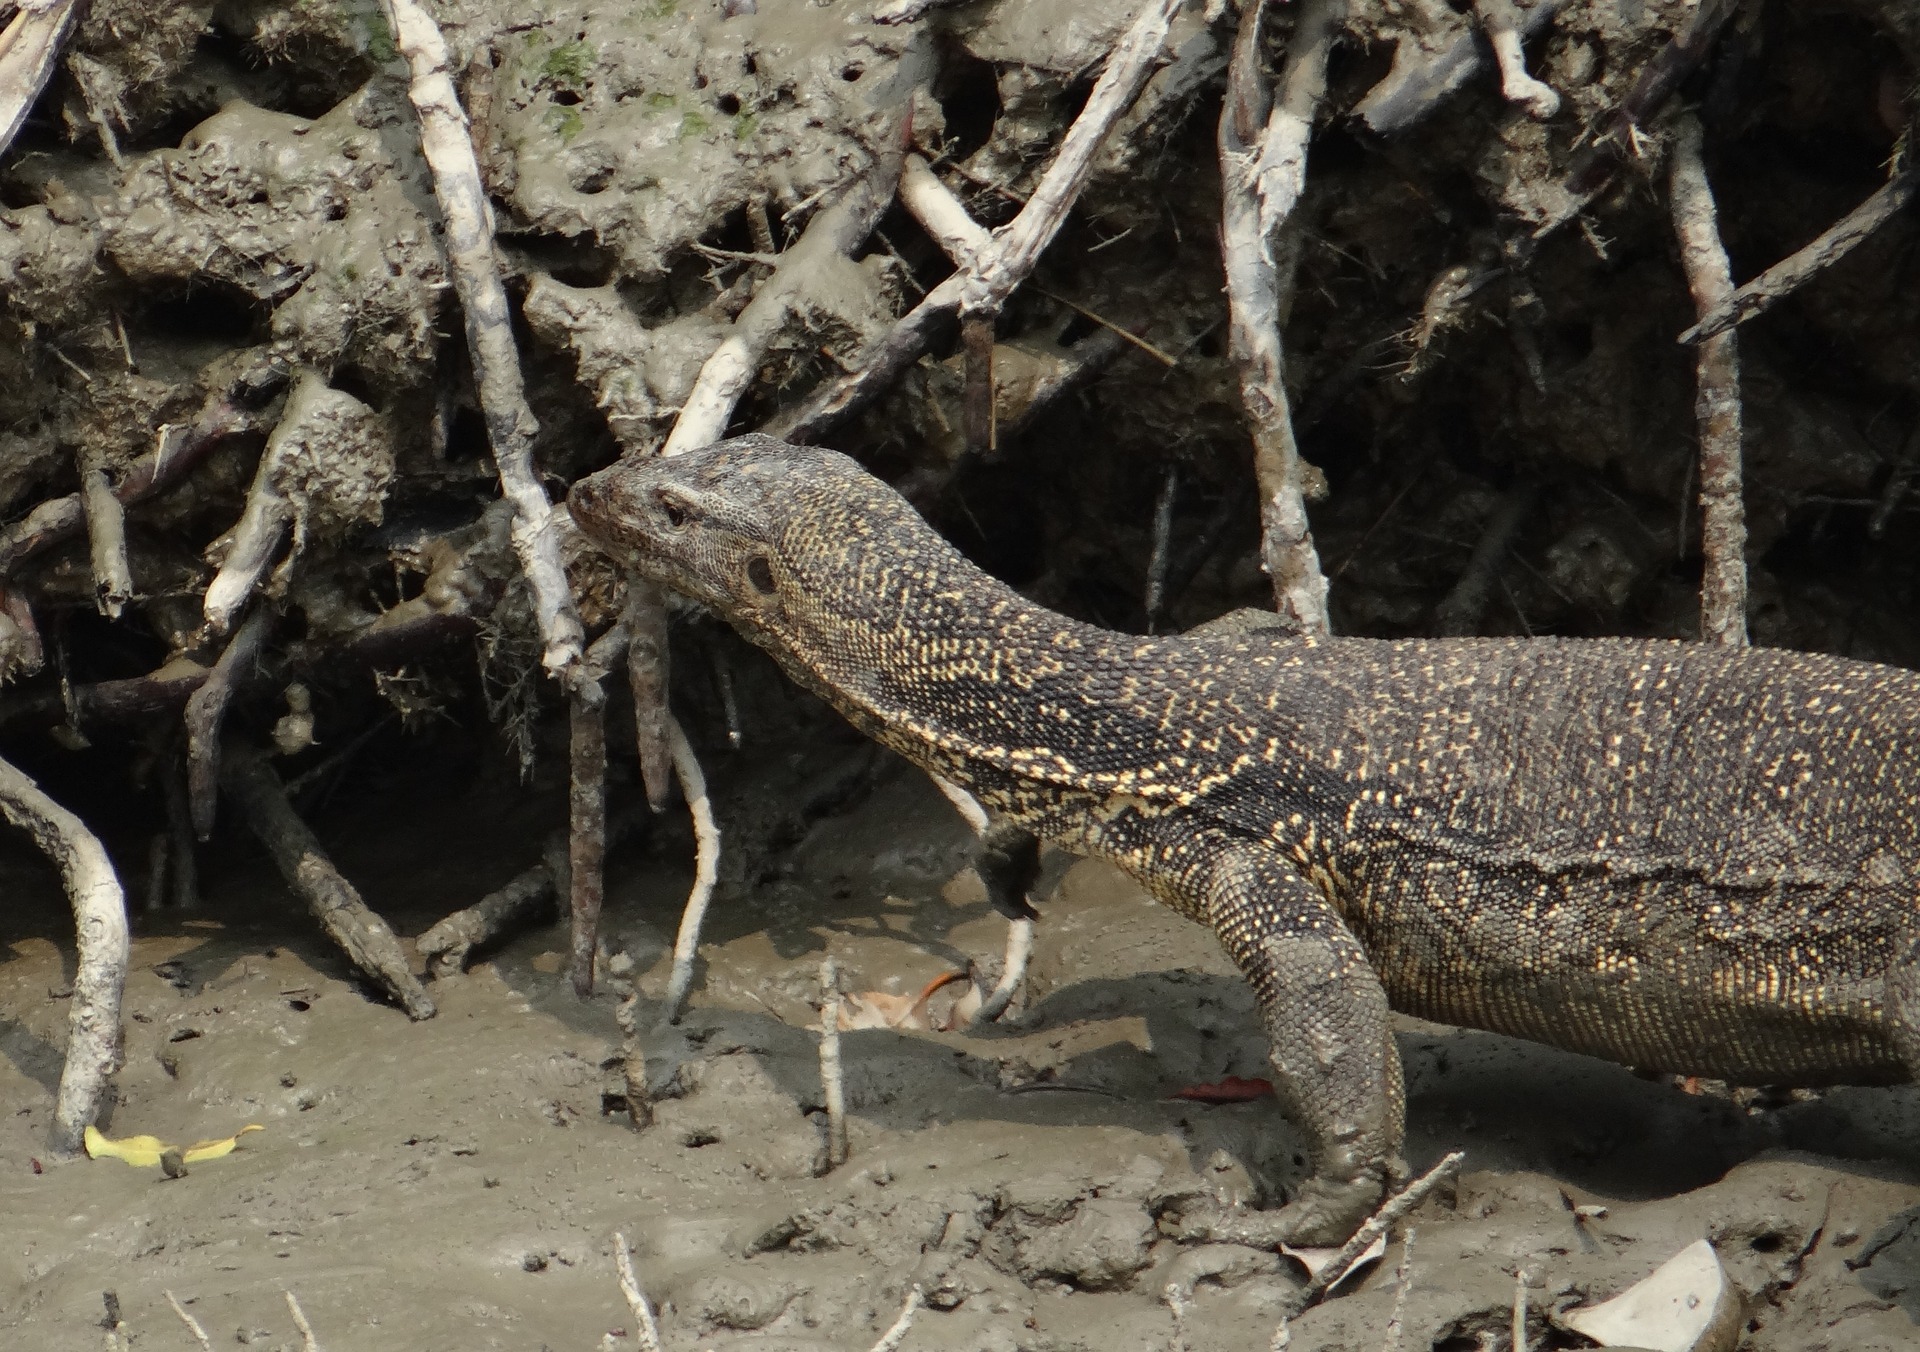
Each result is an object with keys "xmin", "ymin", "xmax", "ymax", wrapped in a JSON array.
[{"xmin": 1175, "ymin": 837, "xmax": 1405, "ymax": 1244}]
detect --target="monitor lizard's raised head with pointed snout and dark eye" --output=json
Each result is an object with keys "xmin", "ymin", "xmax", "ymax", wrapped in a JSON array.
[{"xmin": 566, "ymin": 434, "xmax": 933, "ymax": 649}]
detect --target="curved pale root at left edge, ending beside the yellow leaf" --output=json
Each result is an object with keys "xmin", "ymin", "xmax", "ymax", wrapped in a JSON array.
[{"xmin": 0, "ymin": 748, "xmax": 127, "ymax": 1156}]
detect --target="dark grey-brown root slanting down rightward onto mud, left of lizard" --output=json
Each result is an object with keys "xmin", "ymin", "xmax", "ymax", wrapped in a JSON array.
[{"xmin": 221, "ymin": 743, "xmax": 434, "ymax": 1020}]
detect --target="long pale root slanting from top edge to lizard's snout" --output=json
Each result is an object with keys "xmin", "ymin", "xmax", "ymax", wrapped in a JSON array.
[{"xmin": 382, "ymin": 0, "xmax": 586, "ymax": 672}]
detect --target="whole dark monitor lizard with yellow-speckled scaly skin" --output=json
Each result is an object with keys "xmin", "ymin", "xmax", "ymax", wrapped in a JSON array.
[{"xmin": 570, "ymin": 436, "xmax": 1920, "ymax": 1243}]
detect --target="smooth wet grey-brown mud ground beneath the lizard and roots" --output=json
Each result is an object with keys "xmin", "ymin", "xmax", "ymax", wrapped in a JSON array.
[{"xmin": 0, "ymin": 718, "xmax": 1920, "ymax": 1352}]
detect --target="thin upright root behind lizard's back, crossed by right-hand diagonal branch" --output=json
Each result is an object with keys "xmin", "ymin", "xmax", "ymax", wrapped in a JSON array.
[{"xmin": 1667, "ymin": 113, "xmax": 1747, "ymax": 647}]
